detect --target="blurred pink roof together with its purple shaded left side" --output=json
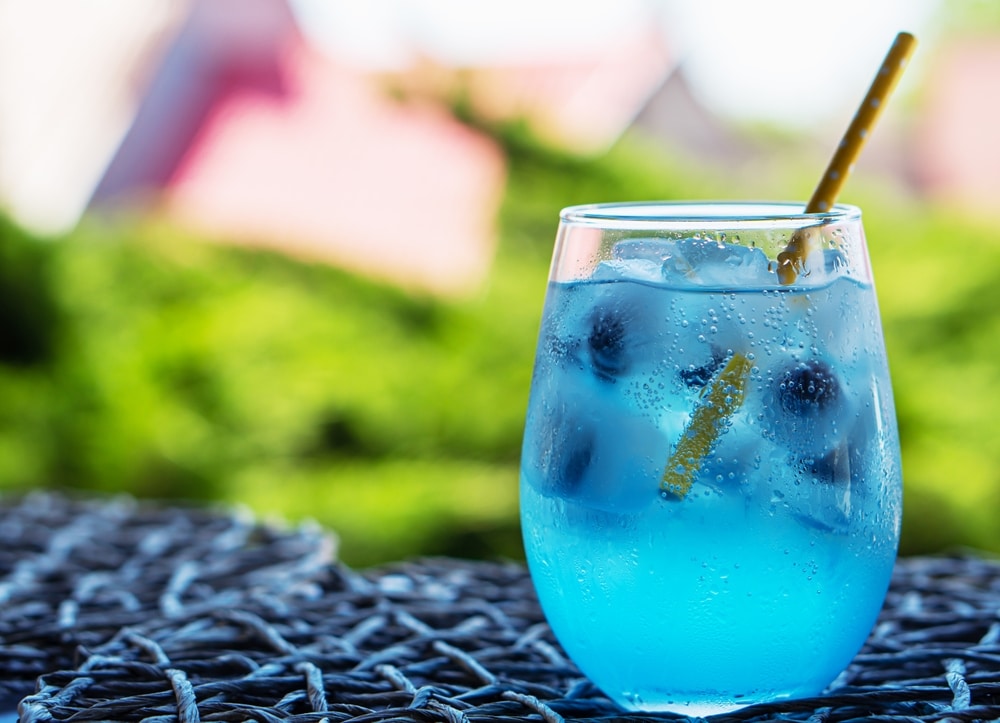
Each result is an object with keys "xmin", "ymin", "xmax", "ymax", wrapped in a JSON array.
[{"xmin": 90, "ymin": 0, "xmax": 505, "ymax": 293}]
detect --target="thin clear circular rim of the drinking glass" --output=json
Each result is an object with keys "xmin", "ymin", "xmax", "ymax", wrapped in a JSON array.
[{"xmin": 559, "ymin": 201, "xmax": 861, "ymax": 229}]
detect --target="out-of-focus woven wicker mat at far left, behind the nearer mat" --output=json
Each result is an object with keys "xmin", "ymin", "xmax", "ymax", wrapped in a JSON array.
[{"xmin": 0, "ymin": 493, "xmax": 334, "ymax": 708}]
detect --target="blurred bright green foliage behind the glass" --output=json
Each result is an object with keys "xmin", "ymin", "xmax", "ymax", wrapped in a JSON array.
[{"xmin": 0, "ymin": 132, "xmax": 1000, "ymax": 565}]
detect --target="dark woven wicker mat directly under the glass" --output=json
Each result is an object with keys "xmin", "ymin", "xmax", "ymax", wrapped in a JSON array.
[{"xmin": 0, "ymin": 494, "xmax": 1000, "ymax": 723}]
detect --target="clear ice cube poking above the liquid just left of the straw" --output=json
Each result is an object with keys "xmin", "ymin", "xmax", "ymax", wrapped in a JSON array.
[{"xmin": 661, "ymin": 237, "xmax": 777, "ymax": 288}]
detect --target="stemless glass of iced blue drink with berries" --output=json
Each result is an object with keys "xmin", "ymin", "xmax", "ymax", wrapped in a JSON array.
[{"xmin": 520, "ymin": 202, "xmax": 902, "ymax": 715}]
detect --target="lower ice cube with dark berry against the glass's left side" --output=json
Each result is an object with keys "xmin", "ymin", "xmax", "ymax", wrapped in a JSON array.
[{"xmin": 524, "ymin": 383, "xmax": 667, "ymax": 513}]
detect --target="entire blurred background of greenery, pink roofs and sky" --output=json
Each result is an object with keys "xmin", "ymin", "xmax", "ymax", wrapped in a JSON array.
[{"xmin": 0, "ymin": 0, "xmax": 1000, "ymax": 565}]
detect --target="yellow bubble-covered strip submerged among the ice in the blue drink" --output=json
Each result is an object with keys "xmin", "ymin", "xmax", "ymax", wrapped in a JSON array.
[{"xmin": 660, "ymin": 353, "xmax": 753, "ymax": 499}]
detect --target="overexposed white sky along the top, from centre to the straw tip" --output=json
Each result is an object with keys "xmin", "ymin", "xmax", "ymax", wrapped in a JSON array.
[{"xmin": 293, "ymin": 0, "xmax": 942, "ymax": 126}]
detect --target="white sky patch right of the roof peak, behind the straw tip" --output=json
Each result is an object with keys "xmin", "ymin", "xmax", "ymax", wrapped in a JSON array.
[{"xmin": 668, "ymin": 0, "xmax": 939, "ymax": 125}]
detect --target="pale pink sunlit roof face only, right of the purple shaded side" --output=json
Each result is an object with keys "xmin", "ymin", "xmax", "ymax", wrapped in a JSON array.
[{"xmin": 166, "ymin": 40, "xmax": 505, "ymax": 292}]
